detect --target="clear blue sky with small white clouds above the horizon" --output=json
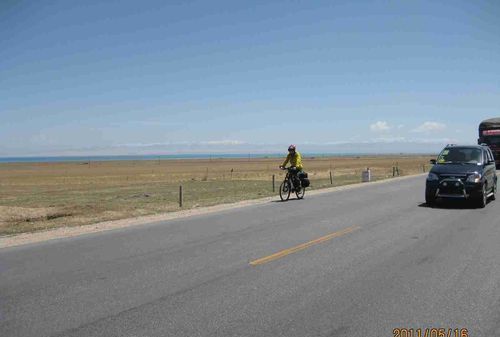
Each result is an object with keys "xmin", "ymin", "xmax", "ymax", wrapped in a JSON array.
[{"xmin": 0, "ymin": 0, "xmax": 500, "ymax": 156}]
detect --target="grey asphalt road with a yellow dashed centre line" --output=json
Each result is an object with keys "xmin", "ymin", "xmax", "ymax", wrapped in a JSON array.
[{"xmin": 0, "ymin": 176, "xmax": 500, "ymax": 337}]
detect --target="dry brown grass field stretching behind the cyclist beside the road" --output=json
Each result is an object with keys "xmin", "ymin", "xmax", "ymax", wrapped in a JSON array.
[{"xmin": 0, "ymin": 156, "xmax": 430, "ymax": 235}]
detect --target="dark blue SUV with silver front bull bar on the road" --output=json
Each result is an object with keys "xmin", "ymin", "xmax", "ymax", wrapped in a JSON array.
[{"xmin": 425, "ymin": 145, "xmax": 497, "ymax": 208}]
